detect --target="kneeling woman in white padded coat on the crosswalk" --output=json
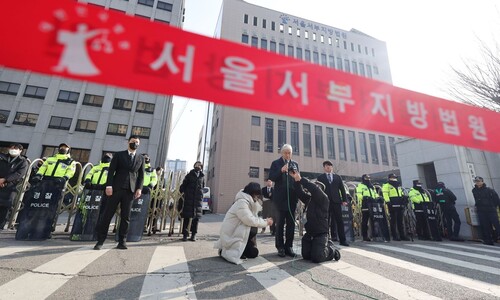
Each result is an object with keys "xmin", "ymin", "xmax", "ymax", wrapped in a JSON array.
[{"xmin": 214, "ymin": 182, "xmax": 273, "ymax": 265}]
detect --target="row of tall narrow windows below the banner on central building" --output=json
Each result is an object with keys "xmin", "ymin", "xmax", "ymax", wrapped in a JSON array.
[{"xmin": 250, "ymin": 116, "xmax": 398, "ymax": 166}]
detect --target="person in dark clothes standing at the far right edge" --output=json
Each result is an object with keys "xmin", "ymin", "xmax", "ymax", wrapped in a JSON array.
[{"xmin": 472, "ymin": 176, "xmax": 500, "ymax": 245}]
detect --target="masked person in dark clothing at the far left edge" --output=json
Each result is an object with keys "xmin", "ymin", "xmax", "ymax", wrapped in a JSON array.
[{"xmin": 0, "ymin": 144, "xmax": 28, "ymax": 230}]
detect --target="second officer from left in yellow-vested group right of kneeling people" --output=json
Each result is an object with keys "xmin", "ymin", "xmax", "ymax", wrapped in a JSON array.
[{"xmin": 382, "ymin": 173, "xmax": 409, "ymax": 241}]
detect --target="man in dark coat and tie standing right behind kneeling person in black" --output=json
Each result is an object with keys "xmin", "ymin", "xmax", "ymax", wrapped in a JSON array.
[{"xmin": 317, "ymin": 160, "xmax": 349, "ymax": 246}]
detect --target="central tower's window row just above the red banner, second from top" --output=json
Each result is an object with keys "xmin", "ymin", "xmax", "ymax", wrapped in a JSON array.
[{"xmin": 241, "ymin": 34, "xmax": 379, "ymax": 78}]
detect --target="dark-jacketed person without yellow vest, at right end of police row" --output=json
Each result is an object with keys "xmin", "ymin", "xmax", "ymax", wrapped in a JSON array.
[{"xmin": 434, "ymin": 181, "xmax": 463, "ymax": 241}]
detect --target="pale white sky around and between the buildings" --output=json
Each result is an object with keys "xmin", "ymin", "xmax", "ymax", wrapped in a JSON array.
[{"xmin": 168, "ymin": 0, "xmax": 500, "ymax": 168}]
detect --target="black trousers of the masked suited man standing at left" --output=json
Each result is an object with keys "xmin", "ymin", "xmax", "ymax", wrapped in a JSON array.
[{"xmin": 96, "ymin": 188, "xmax": 134, "ymax": 243}]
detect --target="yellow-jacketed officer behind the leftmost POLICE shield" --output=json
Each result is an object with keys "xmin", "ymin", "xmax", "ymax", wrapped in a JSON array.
[{"xmin": 31, "ymin": 143, "xmax": 76, "ymax": 188}]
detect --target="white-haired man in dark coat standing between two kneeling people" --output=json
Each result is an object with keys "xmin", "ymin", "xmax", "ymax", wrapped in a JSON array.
[{"xmin": 269, "ymin": 144, "xmax": 299, "ymax": 257}]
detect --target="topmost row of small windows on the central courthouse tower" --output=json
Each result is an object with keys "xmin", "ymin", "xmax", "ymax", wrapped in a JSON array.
[{"xmin": 243, "ymin": 14, "xmax": 375, "ymax": 56}]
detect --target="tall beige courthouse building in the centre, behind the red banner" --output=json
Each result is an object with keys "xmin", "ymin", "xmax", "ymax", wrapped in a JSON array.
[{"xmin": 207, "ymin": 0, "xmax": 398, "ymax": 213}]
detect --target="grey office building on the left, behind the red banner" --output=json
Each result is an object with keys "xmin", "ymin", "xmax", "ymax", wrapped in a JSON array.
[{"xmin": 0, "ymin": 0, "xmax": 184, "ymax": 166}]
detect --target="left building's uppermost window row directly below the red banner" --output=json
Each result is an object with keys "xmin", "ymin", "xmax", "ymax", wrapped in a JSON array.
[{"xmin": 0, "ymin": 81, "xmax": 155, "ymax": 114}]
